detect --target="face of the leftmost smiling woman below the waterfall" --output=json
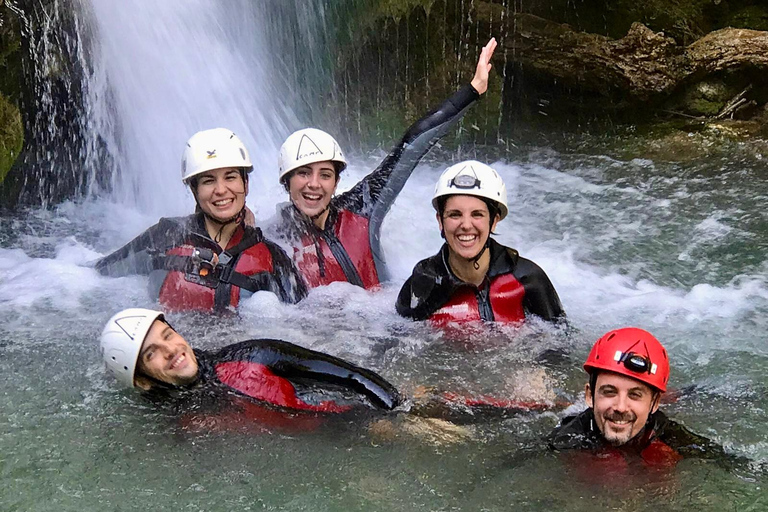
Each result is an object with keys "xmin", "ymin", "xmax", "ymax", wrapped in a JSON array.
[{"xmin": 195, "ymin": 167, "xmax": 248, "ymax": 222}]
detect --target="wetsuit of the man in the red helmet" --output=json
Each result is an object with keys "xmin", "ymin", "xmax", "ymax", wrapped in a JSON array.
[{"xmin": 547, "ymin": 409, "xmax": 735, "ymax": 466}]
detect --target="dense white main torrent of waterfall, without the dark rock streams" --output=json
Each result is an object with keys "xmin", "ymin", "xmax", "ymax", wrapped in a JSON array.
[{"xmin": 82, "ymin": 0, "xmax": 326, "ymax": 215}]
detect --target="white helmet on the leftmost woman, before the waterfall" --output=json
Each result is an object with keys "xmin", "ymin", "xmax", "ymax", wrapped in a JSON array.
[{"xmin": 181, "ymin": 128, "xmax": 253, "ymax": 183}]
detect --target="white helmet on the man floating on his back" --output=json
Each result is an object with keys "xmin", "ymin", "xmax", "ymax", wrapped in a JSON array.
[{"xmin": 101, "ymin": 308, "xmax": 163, "ymax": 388}]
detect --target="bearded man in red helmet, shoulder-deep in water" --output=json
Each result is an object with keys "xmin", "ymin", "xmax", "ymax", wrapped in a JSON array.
[{"xmin": 548, "ymin": 327, "xmax": 732, "ymax": 466}]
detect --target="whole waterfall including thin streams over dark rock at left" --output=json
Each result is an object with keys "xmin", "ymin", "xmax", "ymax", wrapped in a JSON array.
[{"xmin": 11, "ymin": 0, "xmax": 330, "ymax": 215}]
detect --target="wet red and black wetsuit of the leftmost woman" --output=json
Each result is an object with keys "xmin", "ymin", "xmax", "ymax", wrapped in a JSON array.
[{"xmin": 95, "ymin": 213, "xmax": 307, "ymax": 312}]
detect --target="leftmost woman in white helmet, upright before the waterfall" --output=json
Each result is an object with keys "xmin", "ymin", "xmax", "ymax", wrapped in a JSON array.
[{"xmin": 95, "ymin": 128, "xmax": 307, "ymax": 312}]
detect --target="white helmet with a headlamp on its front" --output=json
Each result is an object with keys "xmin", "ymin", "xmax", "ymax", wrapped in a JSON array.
[{"xmin": 432, "ymin": 160, "xmax": 509, "ymax": 220}]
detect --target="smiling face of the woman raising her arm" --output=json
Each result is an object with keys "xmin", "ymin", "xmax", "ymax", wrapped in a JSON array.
[{"xmin": 288, "ymin": 161, "xmax": 339, "ymax": 217}]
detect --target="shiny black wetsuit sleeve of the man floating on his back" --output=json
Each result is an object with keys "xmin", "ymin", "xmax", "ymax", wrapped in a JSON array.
[{"xmin": 228, "ymin": 340, "xmax": 400, "ymax": 410}]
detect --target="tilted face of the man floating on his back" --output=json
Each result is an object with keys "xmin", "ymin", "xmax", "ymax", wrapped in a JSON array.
[{"xmin": 137, "ymin": 320, "xmax": 197, "ymax": 386}]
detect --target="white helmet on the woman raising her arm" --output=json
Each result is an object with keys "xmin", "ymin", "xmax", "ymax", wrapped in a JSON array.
[{"xmin": 277, "ymin": 128, "xmax": 347, "ymax": 183}]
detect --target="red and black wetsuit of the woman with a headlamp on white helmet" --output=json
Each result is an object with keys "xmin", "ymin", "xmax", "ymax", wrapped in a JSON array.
[{"xmin": 395, "ymin": 239, "xmax": 565, "ymax": 326}]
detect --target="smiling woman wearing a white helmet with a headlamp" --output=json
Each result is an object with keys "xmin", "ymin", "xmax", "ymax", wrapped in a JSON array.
[{"xmin": 396, "ymin": 160, "xmax": 565, "ymax": 326}]
